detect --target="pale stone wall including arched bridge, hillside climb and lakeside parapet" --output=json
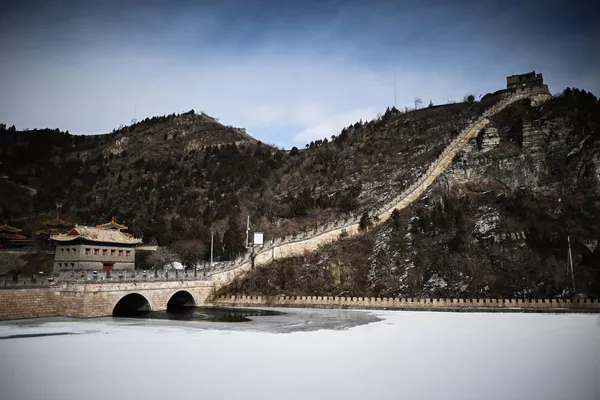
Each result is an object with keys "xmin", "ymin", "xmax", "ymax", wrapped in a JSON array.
[{"xmin": 0, "ymin": 88, "xmax": 584, "ymax": 320}]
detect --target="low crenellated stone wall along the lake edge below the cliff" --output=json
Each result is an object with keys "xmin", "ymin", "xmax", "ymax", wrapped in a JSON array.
[{"xmin": 212, "ymin": 295, "xmax": 600, "ymax": 313}]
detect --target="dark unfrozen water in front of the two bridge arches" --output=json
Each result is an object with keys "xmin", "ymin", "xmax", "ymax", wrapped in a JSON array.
[{"xmin": 119, "ymin": 307, "xmax": 285, "ymax": 322}]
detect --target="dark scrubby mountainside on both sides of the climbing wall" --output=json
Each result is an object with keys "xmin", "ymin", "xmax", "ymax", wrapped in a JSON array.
[{"xmin": 0, "ymin": 89, "xmax": 600, "ymax": 297}]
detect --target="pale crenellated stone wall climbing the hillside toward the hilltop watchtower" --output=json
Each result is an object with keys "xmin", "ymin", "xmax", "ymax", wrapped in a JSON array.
[{"xmin": 209, "ymin": 90, "xmax": 551, "ymax": 288}]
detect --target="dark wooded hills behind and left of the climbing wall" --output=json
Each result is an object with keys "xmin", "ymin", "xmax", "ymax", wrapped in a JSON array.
[{"xmin": 0, "ymin": 102, "xmax": 490, "ymax": 267}]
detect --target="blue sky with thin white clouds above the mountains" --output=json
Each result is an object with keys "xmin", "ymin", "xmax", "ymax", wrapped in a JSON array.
[{"xmin": 0, "ymin": 0, "xmax": 600, "ymax": 148}]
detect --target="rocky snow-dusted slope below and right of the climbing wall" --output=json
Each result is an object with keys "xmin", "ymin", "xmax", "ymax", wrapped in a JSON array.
[{"xmin": 222, "ymin": 89, "xmax": 600, "ymax": 297}]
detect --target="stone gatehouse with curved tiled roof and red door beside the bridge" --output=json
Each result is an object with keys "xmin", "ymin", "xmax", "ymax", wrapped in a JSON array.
[{"xmin": 50, "ymin": 219, "xmax": 142, "ymax": 276}]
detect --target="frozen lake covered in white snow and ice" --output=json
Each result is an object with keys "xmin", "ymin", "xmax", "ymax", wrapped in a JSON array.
[{"xmin": 0, "ymin": 309, "xmax": 600, "ymax": 400}]
